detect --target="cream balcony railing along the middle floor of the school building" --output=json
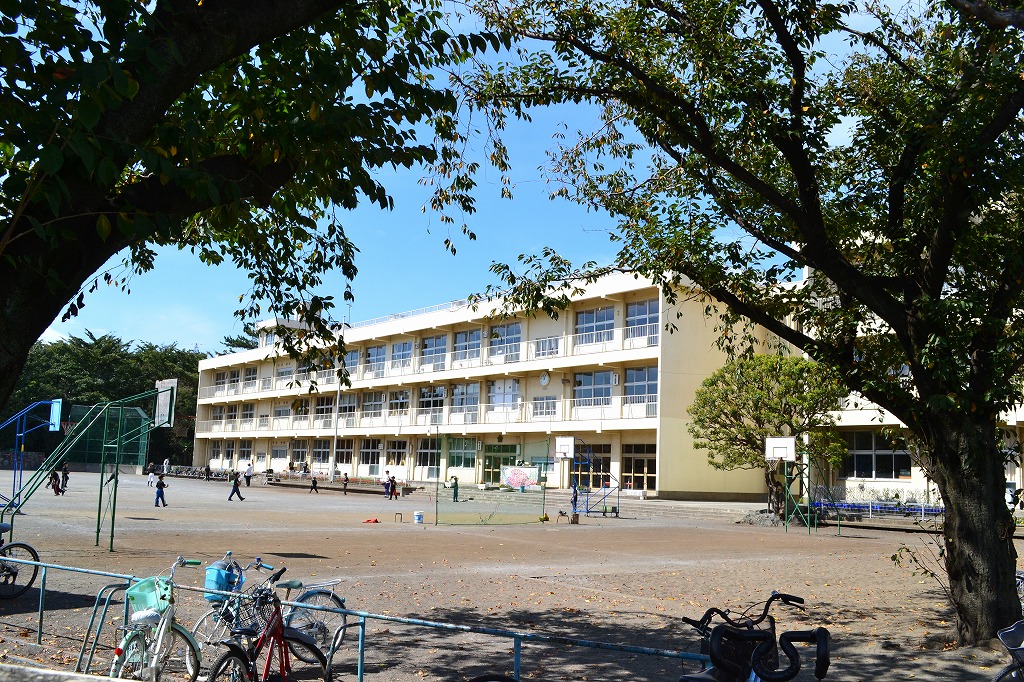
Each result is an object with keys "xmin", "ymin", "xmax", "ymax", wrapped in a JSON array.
[{"xmin": 196, "ymin": 395, "xmax": 657, "ymax": 433}]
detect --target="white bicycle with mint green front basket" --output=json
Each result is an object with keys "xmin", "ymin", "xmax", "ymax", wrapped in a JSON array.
[{"xmin": 111, "ymin": 556, "xmax": 203, "ymax": 682}]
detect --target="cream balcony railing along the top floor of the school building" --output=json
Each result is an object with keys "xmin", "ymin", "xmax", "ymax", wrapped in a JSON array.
[{"xmin": 199, "ymin": 323, "xmax": 660, "ymax": 398}]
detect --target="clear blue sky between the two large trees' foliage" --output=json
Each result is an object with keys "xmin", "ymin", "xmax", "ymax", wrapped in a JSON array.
[{"xmin": 42, "ymin": 110, "xmax": 614, "ymax": 351}]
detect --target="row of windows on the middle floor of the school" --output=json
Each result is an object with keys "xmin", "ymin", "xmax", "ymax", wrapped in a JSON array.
[{"xmin": 210, "ymin": 367, "xmax": 657, "ymax": 421}]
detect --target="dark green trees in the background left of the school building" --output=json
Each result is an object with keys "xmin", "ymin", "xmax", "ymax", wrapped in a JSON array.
[{"xmin": 0, "ymin": 332, "xmax": 206, "ymax": 462}]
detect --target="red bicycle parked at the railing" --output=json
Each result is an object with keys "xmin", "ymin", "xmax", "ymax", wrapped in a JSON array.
[{"xmin": 207, "ymin": 568, "xmax": 330, "ymax": 682}]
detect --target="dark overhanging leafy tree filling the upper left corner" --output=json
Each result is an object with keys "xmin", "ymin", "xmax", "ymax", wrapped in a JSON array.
[{"xmin": 0, "ymin": 0, "xmax": 497, "ymax": 411}]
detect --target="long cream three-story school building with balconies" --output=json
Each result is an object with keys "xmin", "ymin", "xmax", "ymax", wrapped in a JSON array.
[{"xmin": 194, "ymin": 273, "xmax": 764, "ymax": 500}]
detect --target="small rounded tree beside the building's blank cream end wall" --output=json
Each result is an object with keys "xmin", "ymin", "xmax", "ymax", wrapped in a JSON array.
[{"xmin": 688, "ymin": 355, "xmax": 848, "ymax": 512}]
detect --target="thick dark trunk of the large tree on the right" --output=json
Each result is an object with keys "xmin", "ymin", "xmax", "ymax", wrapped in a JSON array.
[{"xmin": 926, "ymin": 415, "xmax": 1021, "ymax": 645}]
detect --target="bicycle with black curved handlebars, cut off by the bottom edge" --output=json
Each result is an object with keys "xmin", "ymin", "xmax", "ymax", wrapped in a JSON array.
[{"xmin": 679, "ymin": 591, "xmax": 827, "ymax": 682}]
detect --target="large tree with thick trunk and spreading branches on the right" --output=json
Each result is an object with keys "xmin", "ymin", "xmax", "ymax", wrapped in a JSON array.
[{"xmin": 466, "ymin": 0, "xmax": 1024, "ymax": 644}]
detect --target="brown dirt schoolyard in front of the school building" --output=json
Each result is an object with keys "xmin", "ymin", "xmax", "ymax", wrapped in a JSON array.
[{"xmin": 0, "ymin": 471, "xmax": 1020, "ymax": 682}]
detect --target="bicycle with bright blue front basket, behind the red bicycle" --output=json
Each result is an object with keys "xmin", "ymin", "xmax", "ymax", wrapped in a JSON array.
[{"xmin": 191, "ymin": 552, "xmax": 348, "ymax": 663}]
